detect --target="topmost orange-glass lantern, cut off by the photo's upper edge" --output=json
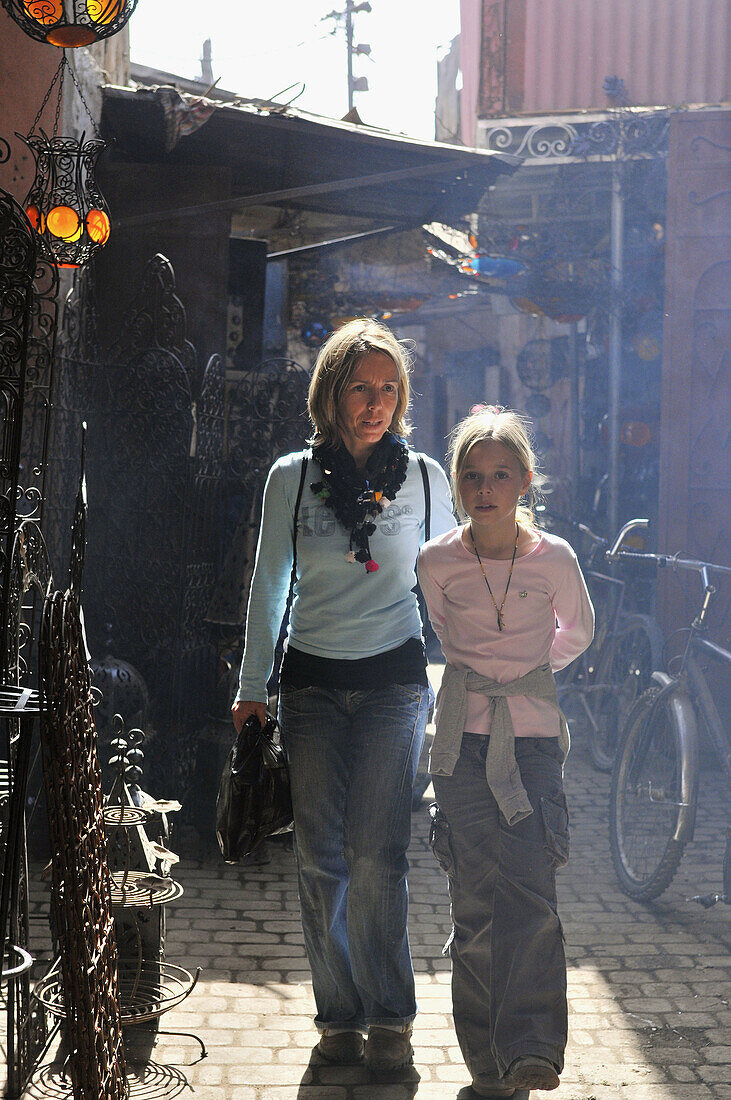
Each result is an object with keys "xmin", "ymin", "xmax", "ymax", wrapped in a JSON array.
[{"xmin": 2, "ymin": 0, "xmax": 137, "ymax": 50}]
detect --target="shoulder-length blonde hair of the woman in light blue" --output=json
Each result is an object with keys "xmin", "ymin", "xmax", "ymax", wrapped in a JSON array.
[{"xmin": 307, "ymin": 317, "xmax": 411, "ymax": 447}]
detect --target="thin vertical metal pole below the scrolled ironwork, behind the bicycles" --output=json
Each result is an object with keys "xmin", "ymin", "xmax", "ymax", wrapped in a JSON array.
[{"xmin": 607, "ymin": 160, "xmax": 624, "ymax": 531}]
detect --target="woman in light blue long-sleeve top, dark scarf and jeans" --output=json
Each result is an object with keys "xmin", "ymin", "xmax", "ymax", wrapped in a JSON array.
[{"xmin": 233, "ymin": 318, "xmax": 454, "ymax": 1073}]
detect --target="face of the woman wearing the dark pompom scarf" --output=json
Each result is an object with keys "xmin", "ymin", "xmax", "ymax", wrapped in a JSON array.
[{"xmin": 337, "ymin": 351, "xmax": 399, "ymax": 464}]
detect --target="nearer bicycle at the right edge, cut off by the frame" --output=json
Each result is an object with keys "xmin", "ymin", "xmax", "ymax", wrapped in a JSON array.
[{"xmin": 607, "ymin": 519, "xmax": 731, "ymax": 906}]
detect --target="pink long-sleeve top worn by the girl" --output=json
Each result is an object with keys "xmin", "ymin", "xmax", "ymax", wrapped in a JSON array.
[{"xmin": 418, "ymin": 527, "xmax": 594, "ymax": 737}]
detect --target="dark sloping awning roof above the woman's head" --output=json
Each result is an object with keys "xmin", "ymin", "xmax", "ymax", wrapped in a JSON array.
[{"xmin": 101, "ymin": 86, "xmax": 520, "ymax": 228}]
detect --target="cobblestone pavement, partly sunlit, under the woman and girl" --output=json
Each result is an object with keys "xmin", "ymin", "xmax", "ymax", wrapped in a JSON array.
[{"xmin": 9, "ymin": 708, "xmax": 731, "ymax": 1100}]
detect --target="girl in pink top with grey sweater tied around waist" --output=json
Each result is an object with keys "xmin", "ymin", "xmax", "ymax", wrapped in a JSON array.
[{"xmin": 419, "ymin": 406, "xmax": 594, "ymax": 1098}]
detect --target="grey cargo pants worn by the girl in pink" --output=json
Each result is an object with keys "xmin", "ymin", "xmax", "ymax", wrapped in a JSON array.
[{"xmin": 431, "ymin": 734, "xmax": 568, "ymax": 1077}]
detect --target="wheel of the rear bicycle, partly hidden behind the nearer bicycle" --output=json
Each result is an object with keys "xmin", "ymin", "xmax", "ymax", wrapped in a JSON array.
[{"xmin": 586, "ymin": 615, "xmax": 663, "ymax": 771}]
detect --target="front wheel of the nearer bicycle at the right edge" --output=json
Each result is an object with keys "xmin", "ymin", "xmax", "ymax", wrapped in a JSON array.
[{"xmin": 609, "ymin": 688, "xmax": 697, "ymax": 901}]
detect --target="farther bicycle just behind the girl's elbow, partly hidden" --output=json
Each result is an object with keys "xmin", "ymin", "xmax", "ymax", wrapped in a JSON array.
[{"xmin": 557, "ymin": 523, "xmax": 663, "ymax": 772}]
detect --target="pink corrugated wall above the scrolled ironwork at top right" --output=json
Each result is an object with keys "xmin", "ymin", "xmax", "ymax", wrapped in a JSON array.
[{"xmin": 461, "ymin": 0, "xmax": 731, "ymax": 135}]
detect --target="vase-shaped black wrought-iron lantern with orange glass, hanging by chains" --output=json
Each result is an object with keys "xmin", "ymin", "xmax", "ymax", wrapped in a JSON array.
[{"xmin": 18, "ymin": 130, "xmax": 111, "ymax": 267}]
